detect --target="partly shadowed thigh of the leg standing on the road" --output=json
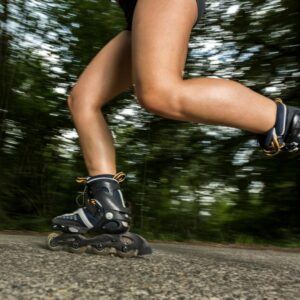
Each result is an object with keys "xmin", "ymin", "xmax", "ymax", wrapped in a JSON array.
[{"xmin": 72, "ymin": 31, "xmax": 132, "ymax": 106}]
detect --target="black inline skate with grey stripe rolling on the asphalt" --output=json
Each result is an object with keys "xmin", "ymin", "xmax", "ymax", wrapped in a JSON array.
[{"xmin": 47, "ymin": 172, "xmax": 152, "ymax": 257}]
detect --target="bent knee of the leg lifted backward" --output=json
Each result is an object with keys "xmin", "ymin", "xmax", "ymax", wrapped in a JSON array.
[{"xmin": 135, "ymin": 82, "xmax": 182, "ymax": 118}]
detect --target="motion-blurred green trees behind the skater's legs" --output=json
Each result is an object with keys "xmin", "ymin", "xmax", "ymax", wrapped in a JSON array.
[{"xmin": 0, "ymin": 0, "xmax": 300, "ymax": 246}]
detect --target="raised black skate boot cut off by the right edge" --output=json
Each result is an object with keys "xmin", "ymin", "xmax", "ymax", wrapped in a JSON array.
[{"xmin": 258, "ymin": 99, "xmax": 300, "ymax": 156}]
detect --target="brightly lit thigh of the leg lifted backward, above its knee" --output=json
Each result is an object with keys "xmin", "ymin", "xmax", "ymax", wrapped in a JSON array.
[{"xmin": 132, "ymin": 0, "xmax": 198, "ymax": 86}]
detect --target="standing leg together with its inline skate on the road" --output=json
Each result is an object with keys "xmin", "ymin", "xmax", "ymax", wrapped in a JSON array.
[{"xmin": 47, "ymin": 30, "xmax": 152, "ymax": 257}]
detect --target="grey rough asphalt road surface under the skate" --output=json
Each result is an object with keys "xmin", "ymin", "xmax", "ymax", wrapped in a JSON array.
[{"xmin": 0, "ymin": 235, "xmax": 300, "ymax": 300}]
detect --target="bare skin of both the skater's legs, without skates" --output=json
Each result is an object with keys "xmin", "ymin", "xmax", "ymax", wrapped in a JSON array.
[{"xmin": 68, "ymin": 0, "xmax": 276, "ymax": 176}]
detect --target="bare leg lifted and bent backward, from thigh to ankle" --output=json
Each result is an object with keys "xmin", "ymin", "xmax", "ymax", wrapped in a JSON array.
[{"xmin": 132, "ymin": 0, "xmax": 276, "ymax": 133}]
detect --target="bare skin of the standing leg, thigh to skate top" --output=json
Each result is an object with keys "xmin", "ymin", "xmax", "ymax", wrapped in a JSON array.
[{"xmin": 68, "ymin": 30, "xmax": 132, "ymax": 176}]
